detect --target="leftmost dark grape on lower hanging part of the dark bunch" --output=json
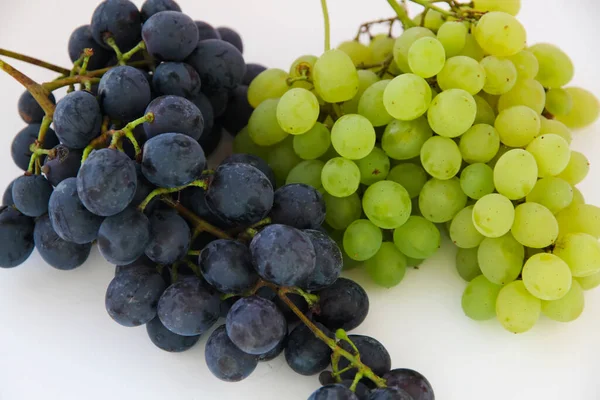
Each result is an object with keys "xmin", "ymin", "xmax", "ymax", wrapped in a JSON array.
[{"xmin": 104, "ymin": 268, "xmax": 165, "ymax": 327}]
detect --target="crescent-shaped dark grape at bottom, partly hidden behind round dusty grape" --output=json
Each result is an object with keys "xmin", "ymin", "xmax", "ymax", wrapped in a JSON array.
[{"xmin": 204, "ymin": 325, "xmax": 258, "ymax": 382}]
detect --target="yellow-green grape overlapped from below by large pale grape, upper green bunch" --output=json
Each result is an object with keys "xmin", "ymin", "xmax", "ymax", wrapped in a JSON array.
[{"xmin": 437, "ymin": 56, "xmax": 486, "ymax": 95}]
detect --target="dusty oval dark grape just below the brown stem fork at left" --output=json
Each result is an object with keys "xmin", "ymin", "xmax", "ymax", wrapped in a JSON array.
[{"xmin": 54, "ymin": 90, "xmax": 102, "ymax": 149}]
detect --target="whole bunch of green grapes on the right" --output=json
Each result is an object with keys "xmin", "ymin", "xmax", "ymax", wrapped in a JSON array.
[{"xmin": 234, "ymin": 0, "xmax": 600, "ymax": 333}]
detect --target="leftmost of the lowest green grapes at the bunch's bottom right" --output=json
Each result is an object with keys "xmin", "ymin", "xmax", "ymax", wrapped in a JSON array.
[{"xmin": 462, "ymin": 275, "xmax": 502, "ymax": 321}]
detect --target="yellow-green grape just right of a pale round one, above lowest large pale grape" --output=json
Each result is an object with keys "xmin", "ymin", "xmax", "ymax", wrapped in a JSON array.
[{"xmin": 510, "ymin": 202, "xmax": 558, "ymax": 249}]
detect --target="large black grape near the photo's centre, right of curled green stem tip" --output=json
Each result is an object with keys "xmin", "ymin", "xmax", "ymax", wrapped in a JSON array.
[{"xmin": 206, "ymin": 163, "xmax": 274, "ymax": 224}]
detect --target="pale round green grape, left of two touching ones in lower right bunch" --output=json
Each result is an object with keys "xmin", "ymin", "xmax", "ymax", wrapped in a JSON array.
[{"xmin": 473, "ymin": 193, "xmax": 515, "ymax": 238}]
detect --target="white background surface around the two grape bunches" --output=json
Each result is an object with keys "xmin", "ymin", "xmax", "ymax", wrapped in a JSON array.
[{"xmin": 0, "ymin": 0, "xmax": 600, "ymax": 400}]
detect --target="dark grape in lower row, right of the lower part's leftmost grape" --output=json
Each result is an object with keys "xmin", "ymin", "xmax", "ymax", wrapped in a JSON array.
[{"xmin": 157, "ymin": 277, "xmax": 221, "ymax": 336}]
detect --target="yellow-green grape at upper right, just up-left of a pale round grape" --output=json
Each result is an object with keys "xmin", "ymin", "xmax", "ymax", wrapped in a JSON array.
[{"xmin": 494, "ymin": 106, "xmax": 540, "ymax": 147}]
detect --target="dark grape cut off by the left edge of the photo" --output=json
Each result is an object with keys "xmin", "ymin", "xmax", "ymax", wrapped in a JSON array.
[{"xmin": 0, "ymin": 206, "xmax": 34, "ymax": 268}]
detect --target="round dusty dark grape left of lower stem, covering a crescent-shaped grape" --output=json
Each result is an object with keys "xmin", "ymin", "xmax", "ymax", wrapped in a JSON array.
[{"xmin": 226, "ymin": 296, "xmax": 287, "ymax": 355}]
